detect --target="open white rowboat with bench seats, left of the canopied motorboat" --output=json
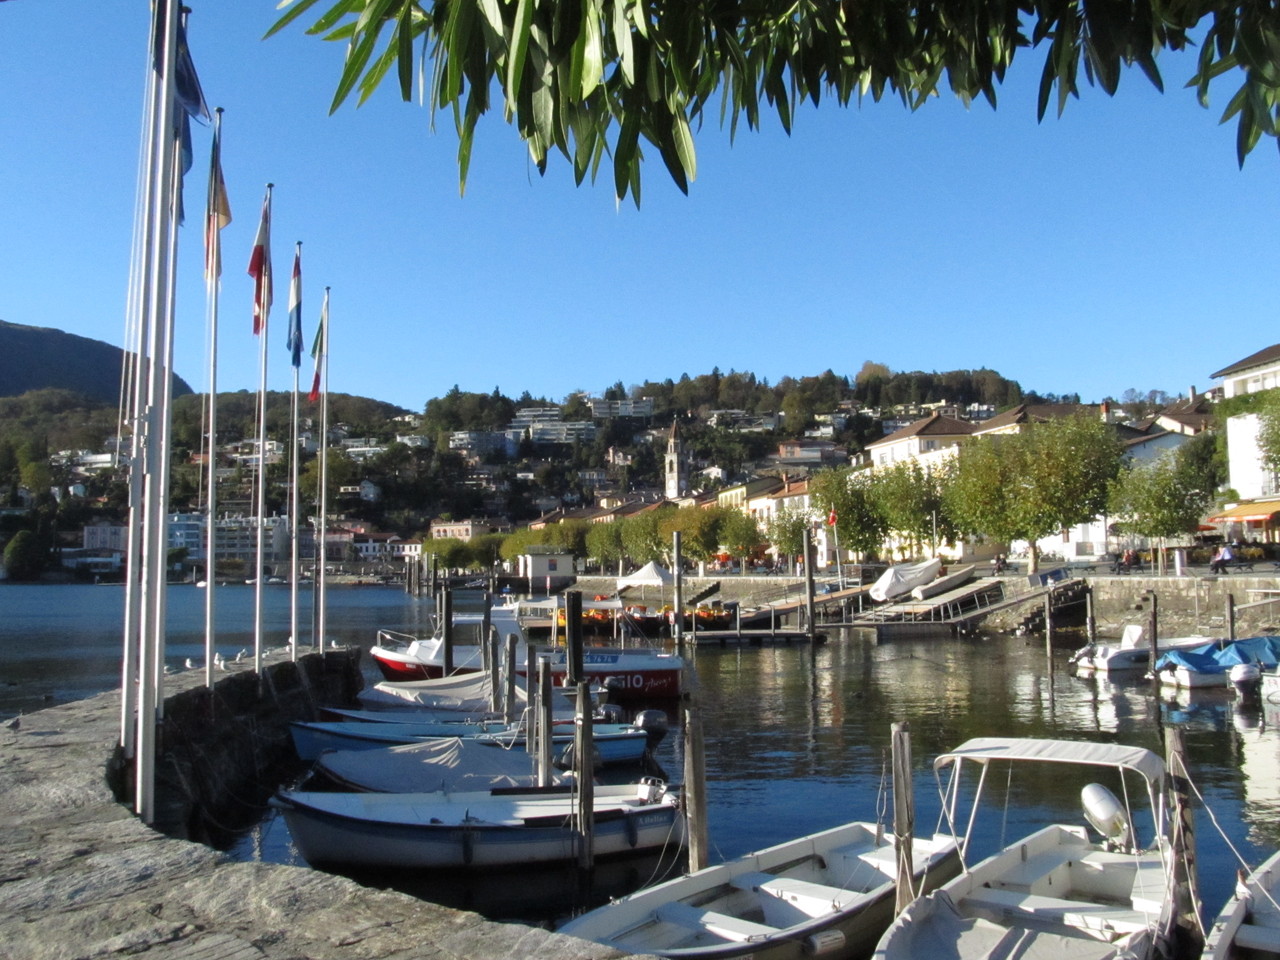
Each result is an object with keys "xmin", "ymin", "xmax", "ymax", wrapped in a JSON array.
[{"xmin": 559, "ymin": 823, "xmax": 960, "ymax": 960}]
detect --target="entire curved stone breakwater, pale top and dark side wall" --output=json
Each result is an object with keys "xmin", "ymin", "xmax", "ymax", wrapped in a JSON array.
[{"xmin": 0, "ymin": 653, "xmax": 645, "ymax": 960}]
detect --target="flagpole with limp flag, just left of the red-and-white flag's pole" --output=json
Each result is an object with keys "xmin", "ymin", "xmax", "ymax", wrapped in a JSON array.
[{"xmin": 205, "ymin": 108, "xmax": 232, "ymax": 687}]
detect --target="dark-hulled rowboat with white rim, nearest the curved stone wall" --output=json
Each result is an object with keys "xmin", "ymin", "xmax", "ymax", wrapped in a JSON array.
[{"xmin": 273, "ymin": 780, "xmax": 685, "ymax": 869}]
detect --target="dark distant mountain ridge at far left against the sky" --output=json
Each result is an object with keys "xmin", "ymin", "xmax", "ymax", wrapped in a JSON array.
[{"xmin": 0, "ymin": 320, "xmax": 191, "ymax": 404}]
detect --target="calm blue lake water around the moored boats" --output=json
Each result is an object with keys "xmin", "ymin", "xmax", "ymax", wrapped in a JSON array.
[{"xmin": 0, "ymin": 585, "xmax": 1280, "ymax": 920}]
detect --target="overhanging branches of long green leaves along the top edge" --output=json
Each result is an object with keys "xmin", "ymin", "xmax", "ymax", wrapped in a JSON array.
[{"xmin": 268, "ymin": 0, "xmax": 1280, "ymax": 205}]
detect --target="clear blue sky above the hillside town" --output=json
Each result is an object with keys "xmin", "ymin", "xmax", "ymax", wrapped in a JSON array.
[{"xmin": 0, "ymin": 0, "xmax": 1280, "ymax": 410}]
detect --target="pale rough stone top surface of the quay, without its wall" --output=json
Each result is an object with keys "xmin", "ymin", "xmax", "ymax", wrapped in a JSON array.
[{"xmin": 0, "ymin": 671, "xmax": 650, "ymax": 960}]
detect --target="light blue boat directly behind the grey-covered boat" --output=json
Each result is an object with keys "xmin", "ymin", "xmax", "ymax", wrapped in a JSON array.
[{"xmin": 289, "ymin": 721, "xmax": 655, "ymax": 764}]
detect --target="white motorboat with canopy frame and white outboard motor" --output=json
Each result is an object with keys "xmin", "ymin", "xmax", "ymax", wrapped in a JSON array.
[{"xmin": 874, "ymin": 737, "xmax": 1171, "ymax": 960}]
